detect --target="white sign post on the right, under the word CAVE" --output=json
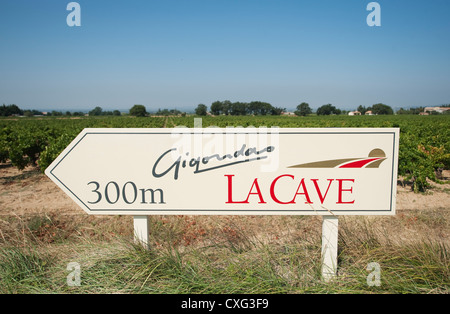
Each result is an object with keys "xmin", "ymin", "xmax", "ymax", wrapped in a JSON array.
[{"xmin": 322, "ymin": 216, "xmax": 339, "ymax": 281}]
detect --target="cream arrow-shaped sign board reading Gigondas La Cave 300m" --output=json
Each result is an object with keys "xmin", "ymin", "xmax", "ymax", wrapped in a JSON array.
[{"xmin": 46, "ymin": 128, "xmax": 399, "ymax": 216}]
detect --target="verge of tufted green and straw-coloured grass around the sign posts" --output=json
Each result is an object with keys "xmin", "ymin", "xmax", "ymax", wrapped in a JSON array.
[{"xmin": 0, "ymin": 217, "xmax": 450, "ymax": 294}]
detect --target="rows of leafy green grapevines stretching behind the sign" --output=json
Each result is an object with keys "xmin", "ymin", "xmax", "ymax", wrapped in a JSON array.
[{"xmin": 0, "ymin": 115, "xmax": 450, "ymax": 192}]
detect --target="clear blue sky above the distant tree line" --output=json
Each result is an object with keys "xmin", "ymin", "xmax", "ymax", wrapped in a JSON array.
[{"xmin": 0, "ymin": 0, "xmax": 450, "ymax": 111}]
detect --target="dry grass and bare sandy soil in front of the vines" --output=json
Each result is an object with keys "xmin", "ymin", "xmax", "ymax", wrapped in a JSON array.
[{"xmin": 0, "ymin": 169, "xmax": 450, "ymax": 294}]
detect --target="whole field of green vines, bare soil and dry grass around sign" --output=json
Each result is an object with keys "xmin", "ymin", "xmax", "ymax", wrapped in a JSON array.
[{"xmin": 0, "ymin": 116, "xmax": 450, "ymax": 293}]
